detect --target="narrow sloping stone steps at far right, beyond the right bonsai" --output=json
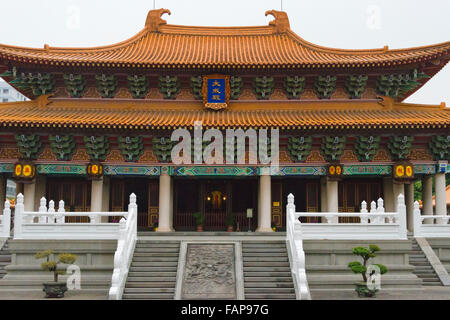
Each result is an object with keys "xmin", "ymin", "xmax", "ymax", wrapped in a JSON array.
[{"xmin": 408, "ymin": 234, "xmax": 442, "ymax": 286}]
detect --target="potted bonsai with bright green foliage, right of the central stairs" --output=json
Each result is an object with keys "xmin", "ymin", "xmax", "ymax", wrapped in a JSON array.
[{"xmin": 348, "ymin": 244, "xmax": 388, "ymax": 297}]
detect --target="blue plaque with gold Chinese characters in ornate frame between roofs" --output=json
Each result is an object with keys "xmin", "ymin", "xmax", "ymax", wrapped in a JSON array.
[{"xmin": 203, "ymin": 75, "xmax": 230, "ymax": 110}]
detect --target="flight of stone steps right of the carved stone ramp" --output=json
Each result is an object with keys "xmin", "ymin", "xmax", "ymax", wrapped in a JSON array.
[{"xmin": 242, "ymin": 240, "xmax": 295, "ymax": 300}]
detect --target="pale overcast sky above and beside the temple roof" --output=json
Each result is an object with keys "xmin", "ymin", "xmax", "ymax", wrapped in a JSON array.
[{"xmin": 0, "ymin": 0, "xmax": 450, "ymax": 106}]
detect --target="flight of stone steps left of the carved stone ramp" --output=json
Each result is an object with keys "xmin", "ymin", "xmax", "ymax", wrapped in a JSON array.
[{"xmin": 122, "ymin": 240, "xmax": 180, "ymax": 300}]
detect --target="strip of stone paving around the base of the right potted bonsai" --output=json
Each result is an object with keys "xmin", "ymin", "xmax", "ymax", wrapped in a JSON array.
[{"xmin": 311, "ymin": 287, "xmax": 450, "ymax": 300}]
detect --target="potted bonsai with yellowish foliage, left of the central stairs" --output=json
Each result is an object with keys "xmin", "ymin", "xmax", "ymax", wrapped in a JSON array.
[{"xmin": 35, "ymin": 250, "xmax": 77, "ymax": 298}]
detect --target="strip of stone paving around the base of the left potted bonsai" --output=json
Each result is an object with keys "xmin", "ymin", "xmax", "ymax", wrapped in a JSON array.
[{"xmin": 0, "ymin": 291, "xmax": 107, "ymax": 300}]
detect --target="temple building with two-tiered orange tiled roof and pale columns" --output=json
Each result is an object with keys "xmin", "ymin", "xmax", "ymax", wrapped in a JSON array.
[{"xmin": 0, "ymin": 9, "xmax": 450, "ymax": 232}]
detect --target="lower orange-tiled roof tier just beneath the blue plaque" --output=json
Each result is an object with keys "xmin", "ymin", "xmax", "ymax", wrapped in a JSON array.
[{"xmin": 0, "ymin": 96, "xmax": 450, "ymax": 130}]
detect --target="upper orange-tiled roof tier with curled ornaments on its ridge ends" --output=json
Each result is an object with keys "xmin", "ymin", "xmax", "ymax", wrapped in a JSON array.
[{"xmin": 0, "ymin": 9, "xmax": 450, "ymax": 69}]
